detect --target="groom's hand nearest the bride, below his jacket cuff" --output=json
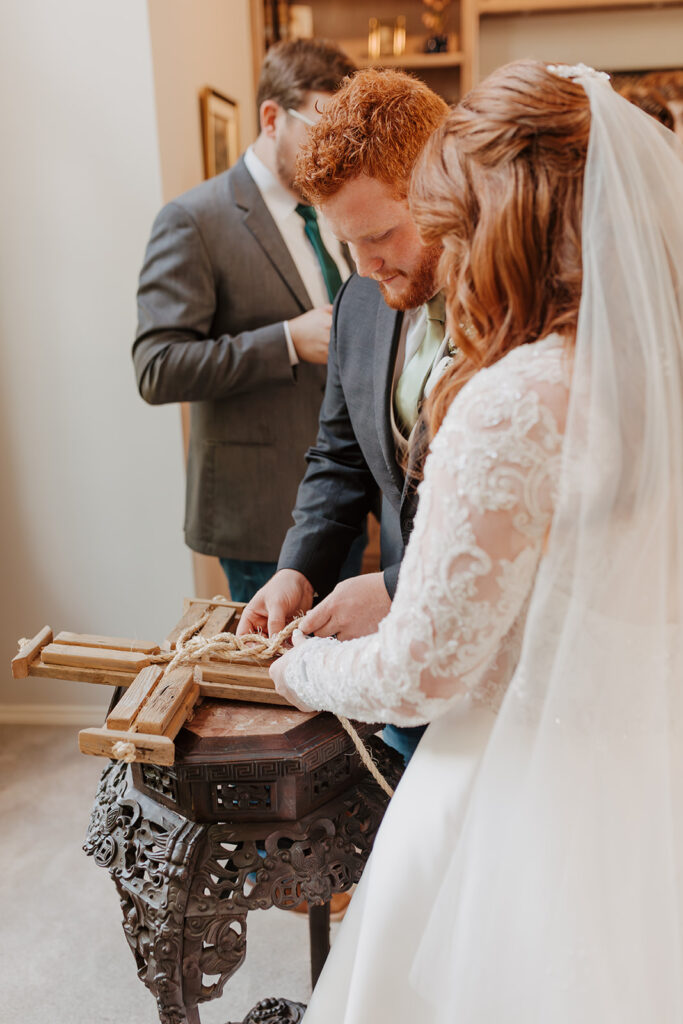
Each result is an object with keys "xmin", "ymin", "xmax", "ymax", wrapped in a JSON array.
[{"xmin": 299, "ymin": 572, "xmax": 391, "ymax": 640}]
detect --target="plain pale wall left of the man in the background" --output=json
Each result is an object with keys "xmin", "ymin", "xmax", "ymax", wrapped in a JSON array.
[{"xmin": 0, "ymin": 0, "xmax": 259, "ymax": 724}]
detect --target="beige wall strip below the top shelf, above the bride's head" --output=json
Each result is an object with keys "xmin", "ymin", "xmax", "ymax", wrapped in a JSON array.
[{"xmin": 480, "ymin": 7, "xmax": 683, "ymax": 78}]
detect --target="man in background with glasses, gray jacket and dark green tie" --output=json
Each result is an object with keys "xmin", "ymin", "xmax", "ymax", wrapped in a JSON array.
[{"xmin": 133, "ymin": 39, "xmax": 362, "ymax": 601}]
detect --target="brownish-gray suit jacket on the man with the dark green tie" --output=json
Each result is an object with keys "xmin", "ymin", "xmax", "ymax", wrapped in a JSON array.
[{"xmin": 133, "ymin": 160, "xmax": 333, "ymax": 561}]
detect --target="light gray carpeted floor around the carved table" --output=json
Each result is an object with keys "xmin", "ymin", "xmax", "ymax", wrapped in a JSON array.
[{"xmin": 0, "ymin": 726, "xmax": 335, "ymax": 1024}]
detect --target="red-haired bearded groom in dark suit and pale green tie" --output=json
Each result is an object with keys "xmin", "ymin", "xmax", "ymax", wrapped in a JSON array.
[{"xmin": 240, "ymin": 70, "xmax": 447, "ymax": 758}]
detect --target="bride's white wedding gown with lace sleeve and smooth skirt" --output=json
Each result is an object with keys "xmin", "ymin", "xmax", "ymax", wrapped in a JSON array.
[{"xmin": 287, "ymin": 336, "xmax": 570, "ymax": 1024}]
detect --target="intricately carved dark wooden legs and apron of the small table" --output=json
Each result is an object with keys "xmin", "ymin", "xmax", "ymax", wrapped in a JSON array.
[{"xmin": 84, "ymin": 749, "xmax": 400, "ymax": 1024}]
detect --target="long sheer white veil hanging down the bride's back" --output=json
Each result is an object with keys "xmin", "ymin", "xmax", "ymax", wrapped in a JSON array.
[{"xmin": 412, "ymin": 66, "xmax": 683, "ymax": 1024}]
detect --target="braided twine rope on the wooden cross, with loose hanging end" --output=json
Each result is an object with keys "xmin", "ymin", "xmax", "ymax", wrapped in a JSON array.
[{"xmin": 152, "ymin": 610, "xmax": 393, "ymax": 797}]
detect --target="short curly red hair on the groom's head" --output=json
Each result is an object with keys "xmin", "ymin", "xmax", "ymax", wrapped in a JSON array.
[{"xmin": 295, "ymin": 68, "xmax": 449, "ymax": 205}]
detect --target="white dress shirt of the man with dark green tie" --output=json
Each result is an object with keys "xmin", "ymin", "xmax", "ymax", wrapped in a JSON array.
[{"xmin": 245, "ymin": 145, "xmax": 351, "ymax": 366}]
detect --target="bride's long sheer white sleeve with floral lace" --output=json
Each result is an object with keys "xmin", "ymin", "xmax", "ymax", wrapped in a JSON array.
[{"xmin": 286, "ymin": 337, "xmax": 569, "ymax": 725}]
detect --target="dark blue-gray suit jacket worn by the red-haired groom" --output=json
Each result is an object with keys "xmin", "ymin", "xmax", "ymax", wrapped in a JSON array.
[{"xmin": 279, "ymin": 274, "xmax": 417, "ymax": 597}]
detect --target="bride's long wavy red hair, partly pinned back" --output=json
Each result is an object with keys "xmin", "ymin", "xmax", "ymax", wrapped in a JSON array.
[{"xmin": 410, "ymin": 60, "xmax": 591, "ymax": 435}]
